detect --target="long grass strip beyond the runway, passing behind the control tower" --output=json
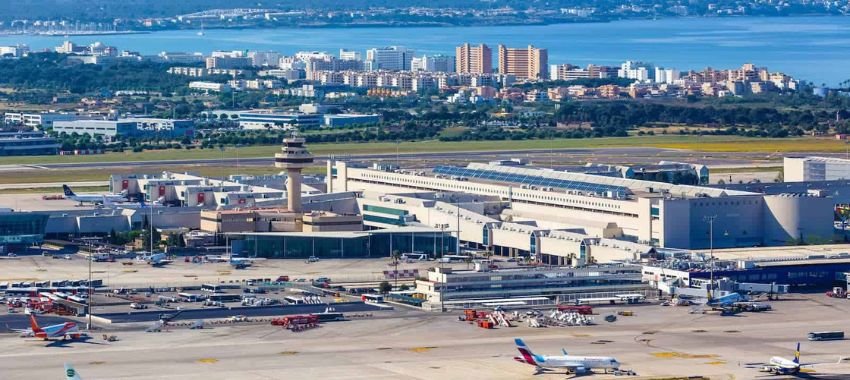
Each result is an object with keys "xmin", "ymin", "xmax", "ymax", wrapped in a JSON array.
[{"xmin": 0, "ymin": 136, "xmax": 847, "ymax": 165}]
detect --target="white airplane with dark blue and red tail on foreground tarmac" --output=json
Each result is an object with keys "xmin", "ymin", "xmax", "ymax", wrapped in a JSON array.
[{"xmin": 514, "ymin": 338, "xmax": 620, "ymax": 375}]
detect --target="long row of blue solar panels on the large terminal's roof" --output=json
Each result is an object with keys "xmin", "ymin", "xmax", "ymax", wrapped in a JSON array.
[{"xmin": 434, "ymin": 165, "xmax": 629, "ymax": 196}]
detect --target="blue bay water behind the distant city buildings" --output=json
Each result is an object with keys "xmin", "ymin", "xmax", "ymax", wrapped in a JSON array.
[{"xmin": 0, "ymin": 17, "xmax": 850, "ymax": 85}]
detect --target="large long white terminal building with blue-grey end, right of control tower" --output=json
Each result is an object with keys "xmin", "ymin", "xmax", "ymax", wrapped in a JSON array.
[{"xmin": 328, "ymin": 161, "xmax": 835, "ymax": 253}]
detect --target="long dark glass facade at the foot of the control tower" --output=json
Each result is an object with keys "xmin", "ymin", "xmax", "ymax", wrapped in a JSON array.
[{"xmin": 231, "ymin": 232, "xmax": 456, "ymax": 259}]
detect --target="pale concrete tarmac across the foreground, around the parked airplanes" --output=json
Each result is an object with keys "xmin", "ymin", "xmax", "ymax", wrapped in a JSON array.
[{"xmin": 0, "ymin": 294, "xmax": 850, "ymax": 380}]
